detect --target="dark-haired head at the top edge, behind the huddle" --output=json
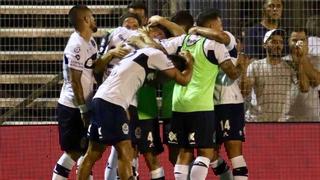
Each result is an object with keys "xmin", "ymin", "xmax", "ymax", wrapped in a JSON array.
[{"xmin": 127, "ymin": 1, "xmax": 148, "ymax": 26}]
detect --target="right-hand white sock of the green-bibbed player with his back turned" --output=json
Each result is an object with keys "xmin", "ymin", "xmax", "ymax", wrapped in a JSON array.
[{"xmin": 190, "ymin": 156, "xmax": 210, "ymax": 180}]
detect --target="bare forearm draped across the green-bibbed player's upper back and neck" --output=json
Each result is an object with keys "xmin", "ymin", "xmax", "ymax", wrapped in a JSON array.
[{"xmin": 189, "ymin": 26, "xmax": 230, "ymax": 46}]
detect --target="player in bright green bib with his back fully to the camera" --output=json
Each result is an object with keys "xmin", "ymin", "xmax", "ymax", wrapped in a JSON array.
[{"xmin": 162, "ymin": 11, "xmax": 246, "ymax": 180}]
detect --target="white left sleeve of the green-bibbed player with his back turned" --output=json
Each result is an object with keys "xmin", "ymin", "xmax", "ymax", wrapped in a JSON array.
[{"xmin": 160, "ymin": 35, "xmax": 186, "ymax": 54}]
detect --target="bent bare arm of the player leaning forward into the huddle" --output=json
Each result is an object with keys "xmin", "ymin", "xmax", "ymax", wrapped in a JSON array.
[{"xmin": 161, "ymin": 51, "xmax": 194, "ymax": 86}]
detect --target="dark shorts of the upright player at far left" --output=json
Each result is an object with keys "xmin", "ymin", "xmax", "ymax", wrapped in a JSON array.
[{"xmin": 57, "ymin": 103, "xmax": 88, "ymax": 152}]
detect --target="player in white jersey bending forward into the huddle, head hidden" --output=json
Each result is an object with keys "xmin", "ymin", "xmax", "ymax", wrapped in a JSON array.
[{"xmin": 78, "ymin": 45, "xmax": 193, "ymax": 180}]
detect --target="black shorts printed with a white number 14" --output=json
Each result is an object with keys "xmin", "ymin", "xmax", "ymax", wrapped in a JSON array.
[{"xmin": 215, "ymin": 103, "xmax": 245, "ymax": 144}]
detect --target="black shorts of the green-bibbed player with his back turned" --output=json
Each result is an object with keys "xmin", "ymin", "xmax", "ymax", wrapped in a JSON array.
[{"xmin": 168, "ymin": 111, "xmax": 216, "ymax": 148}]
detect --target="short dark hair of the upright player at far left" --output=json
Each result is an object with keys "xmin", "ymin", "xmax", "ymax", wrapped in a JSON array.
[{"xmin": 69, "ymin": 5, "xmax": 90, "ymax": 29}]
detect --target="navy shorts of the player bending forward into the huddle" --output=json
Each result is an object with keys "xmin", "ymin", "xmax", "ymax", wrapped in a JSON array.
[{"xmin": 88, "ymin": 98, "xmax": 131, "ymax": 145}]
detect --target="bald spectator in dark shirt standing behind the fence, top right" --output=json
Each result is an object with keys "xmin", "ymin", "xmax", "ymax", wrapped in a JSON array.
[{"xmin": 243, "ymin": 0, "xmax": 283, "ymax": 59}]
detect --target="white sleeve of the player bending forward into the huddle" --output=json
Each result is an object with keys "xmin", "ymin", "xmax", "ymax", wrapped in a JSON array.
[{"xmin": 148, "ymin": 50, "xmax": 174, "ymax": 71}]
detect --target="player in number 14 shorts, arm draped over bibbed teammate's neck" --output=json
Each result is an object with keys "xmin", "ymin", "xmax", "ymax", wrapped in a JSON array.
[{"xmin": 189, "ymin": 11, "xmax": 248, "ymax": 180}]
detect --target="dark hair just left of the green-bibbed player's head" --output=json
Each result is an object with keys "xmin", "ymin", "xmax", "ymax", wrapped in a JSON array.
[{"xmin": 171, "ymin": 10, "xmax": 194, "ymax": 31}]
